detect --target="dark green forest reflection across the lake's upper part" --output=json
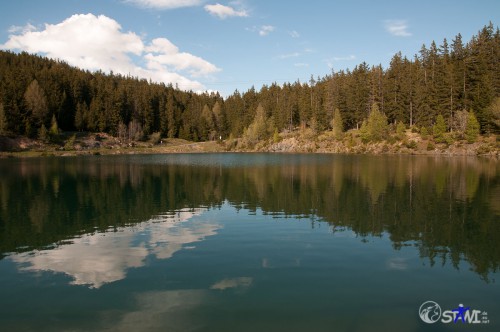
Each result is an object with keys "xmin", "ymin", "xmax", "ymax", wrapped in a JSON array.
[{"xmin": 0, "ymin": 154, "xmax": 500, "ymax": 280}]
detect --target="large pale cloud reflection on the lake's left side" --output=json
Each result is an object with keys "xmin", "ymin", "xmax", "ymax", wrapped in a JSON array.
[{"xmin": 10, "ymin": 209, "xmax": 221, "ymax": 288}]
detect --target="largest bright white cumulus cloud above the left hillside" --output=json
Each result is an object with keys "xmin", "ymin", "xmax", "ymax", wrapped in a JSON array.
[{"xmin": 0, "ymin": 14, "xmax": 220, "ymax": 90}]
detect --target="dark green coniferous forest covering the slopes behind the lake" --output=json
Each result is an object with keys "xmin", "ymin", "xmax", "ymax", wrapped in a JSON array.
[{"xmin": 0, "ymin": 23, "xmax": 500, "ymax": 141}]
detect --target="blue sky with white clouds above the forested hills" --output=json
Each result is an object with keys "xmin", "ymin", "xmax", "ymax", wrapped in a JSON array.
[{"xmin": 0, "ymin": 0, "xmax": 500, "ymax": 96}]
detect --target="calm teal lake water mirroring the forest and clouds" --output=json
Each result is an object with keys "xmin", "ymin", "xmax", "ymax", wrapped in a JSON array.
[{"xmin": 0, "ymin": 154, "xmax": 500, "ymax": 332}]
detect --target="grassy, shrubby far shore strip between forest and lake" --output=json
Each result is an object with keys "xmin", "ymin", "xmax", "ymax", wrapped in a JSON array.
[{"xmin": 0, "ymin": 132, "xmax": 500, "ymax": 158}]
